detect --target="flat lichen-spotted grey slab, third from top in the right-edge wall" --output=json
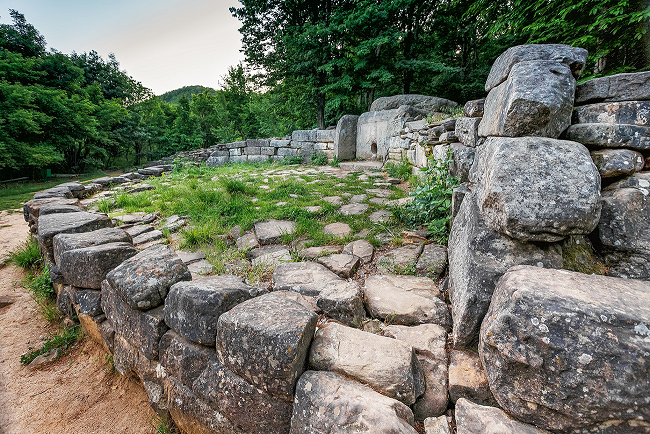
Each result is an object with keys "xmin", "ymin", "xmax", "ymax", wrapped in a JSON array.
[{"xmin": 565, "ymin": 124, "xmax": 650, "ymax": 151}]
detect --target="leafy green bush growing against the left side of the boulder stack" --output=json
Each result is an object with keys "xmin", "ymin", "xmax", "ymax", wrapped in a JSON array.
[{"xmin": 394, "ymin": 151, "xmax": 458, "ymax": 244}]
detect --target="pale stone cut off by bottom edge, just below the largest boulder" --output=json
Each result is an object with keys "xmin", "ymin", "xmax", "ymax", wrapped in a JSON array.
[{"xmin": 456, "ymin": 398, "xmax": 549, "ymax": 434}]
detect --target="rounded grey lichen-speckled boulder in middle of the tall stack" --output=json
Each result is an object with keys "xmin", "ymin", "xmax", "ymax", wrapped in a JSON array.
[{"xmin": 470, "ymin": 137, "xmax": 600, "ymax": 242}]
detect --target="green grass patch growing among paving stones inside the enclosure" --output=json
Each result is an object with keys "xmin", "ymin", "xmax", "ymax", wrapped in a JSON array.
[{"xmin": 98, "ymin": 163, "xmax": 407, "ymax": 282}]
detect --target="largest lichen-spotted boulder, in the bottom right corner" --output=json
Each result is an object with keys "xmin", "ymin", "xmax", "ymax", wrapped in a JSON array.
[{"xmin": 479, "ymin": 266, "xmax": 650, "ymax": 431}]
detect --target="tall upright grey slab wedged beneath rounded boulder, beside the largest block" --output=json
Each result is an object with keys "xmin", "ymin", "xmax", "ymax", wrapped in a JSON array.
[{"xmin": 448, "ymin": 193, "xmax": 562, "ymax": 348}]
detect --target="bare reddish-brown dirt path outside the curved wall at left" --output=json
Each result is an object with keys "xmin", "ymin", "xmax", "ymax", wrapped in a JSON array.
[{"xmin": 0, "ymin": 211, "xmax": 155, "ymax": 434}]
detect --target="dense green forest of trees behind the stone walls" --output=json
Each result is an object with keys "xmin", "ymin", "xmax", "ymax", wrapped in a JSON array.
[{"xmin": 0, "ymin": 0, "xmax": 650, "ymax": 180}]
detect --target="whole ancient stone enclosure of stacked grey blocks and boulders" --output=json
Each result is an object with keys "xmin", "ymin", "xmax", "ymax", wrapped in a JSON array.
[{"xmin": 24, "ymin": 45, "xmax": 650, "ymax": 434}]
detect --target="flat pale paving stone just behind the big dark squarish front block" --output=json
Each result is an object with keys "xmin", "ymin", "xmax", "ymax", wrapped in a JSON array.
[{"xmin": 273, "ymin": 262, "xmax": 342, "ymax": 297}]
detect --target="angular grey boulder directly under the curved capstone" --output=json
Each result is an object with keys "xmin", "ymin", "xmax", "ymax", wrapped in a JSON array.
[{"xmin": 478, "ymin": 60, "xmax": 576, "ymax": 139}]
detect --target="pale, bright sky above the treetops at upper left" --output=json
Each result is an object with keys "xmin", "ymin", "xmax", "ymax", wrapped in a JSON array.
[{"xmin": 0, "ymin": 0, "xmax": 244, "ymax": 95}]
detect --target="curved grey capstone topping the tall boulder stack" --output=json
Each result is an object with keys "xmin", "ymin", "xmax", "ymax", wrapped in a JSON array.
[{"xmin": 485, "ymin": 44, "xmax": 588, "ymax": 91}]
